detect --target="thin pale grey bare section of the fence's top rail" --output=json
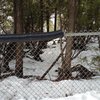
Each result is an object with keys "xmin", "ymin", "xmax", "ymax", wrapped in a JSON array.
[{"xmin": 64, "ymin": 32, "xmax": 100, "ymax": 37}]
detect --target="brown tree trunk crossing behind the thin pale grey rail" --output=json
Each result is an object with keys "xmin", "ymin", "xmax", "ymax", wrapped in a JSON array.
[{"xmin": 62, "ymin": 0, "xmax": 76, "ymax": 79}]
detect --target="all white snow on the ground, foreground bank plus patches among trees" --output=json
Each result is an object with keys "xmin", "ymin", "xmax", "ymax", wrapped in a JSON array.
[{"xmin": 0, "ymin": 38, "xmax": 100, "ymax": 100}]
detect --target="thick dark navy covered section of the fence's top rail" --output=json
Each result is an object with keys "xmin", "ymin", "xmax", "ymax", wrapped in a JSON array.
[{"xmin": 0, "ymin": 30, "xmax": 64, "ymax": 42}]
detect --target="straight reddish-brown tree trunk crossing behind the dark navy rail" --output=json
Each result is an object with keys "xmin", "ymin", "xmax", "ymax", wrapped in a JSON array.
[{"xmin": 14, "ymin": 0, "xmax": 23, "ymax": 77}]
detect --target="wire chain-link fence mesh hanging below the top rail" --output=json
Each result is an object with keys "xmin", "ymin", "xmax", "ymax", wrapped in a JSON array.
[{"xmin": 0, "ymin": 31, "xmax": 100, "ymax": 100}]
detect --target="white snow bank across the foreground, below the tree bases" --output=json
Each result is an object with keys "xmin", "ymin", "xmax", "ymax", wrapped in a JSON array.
[{"xmin": 0, "ymin": 77, "xmax": 100, "ymax": 100}]
